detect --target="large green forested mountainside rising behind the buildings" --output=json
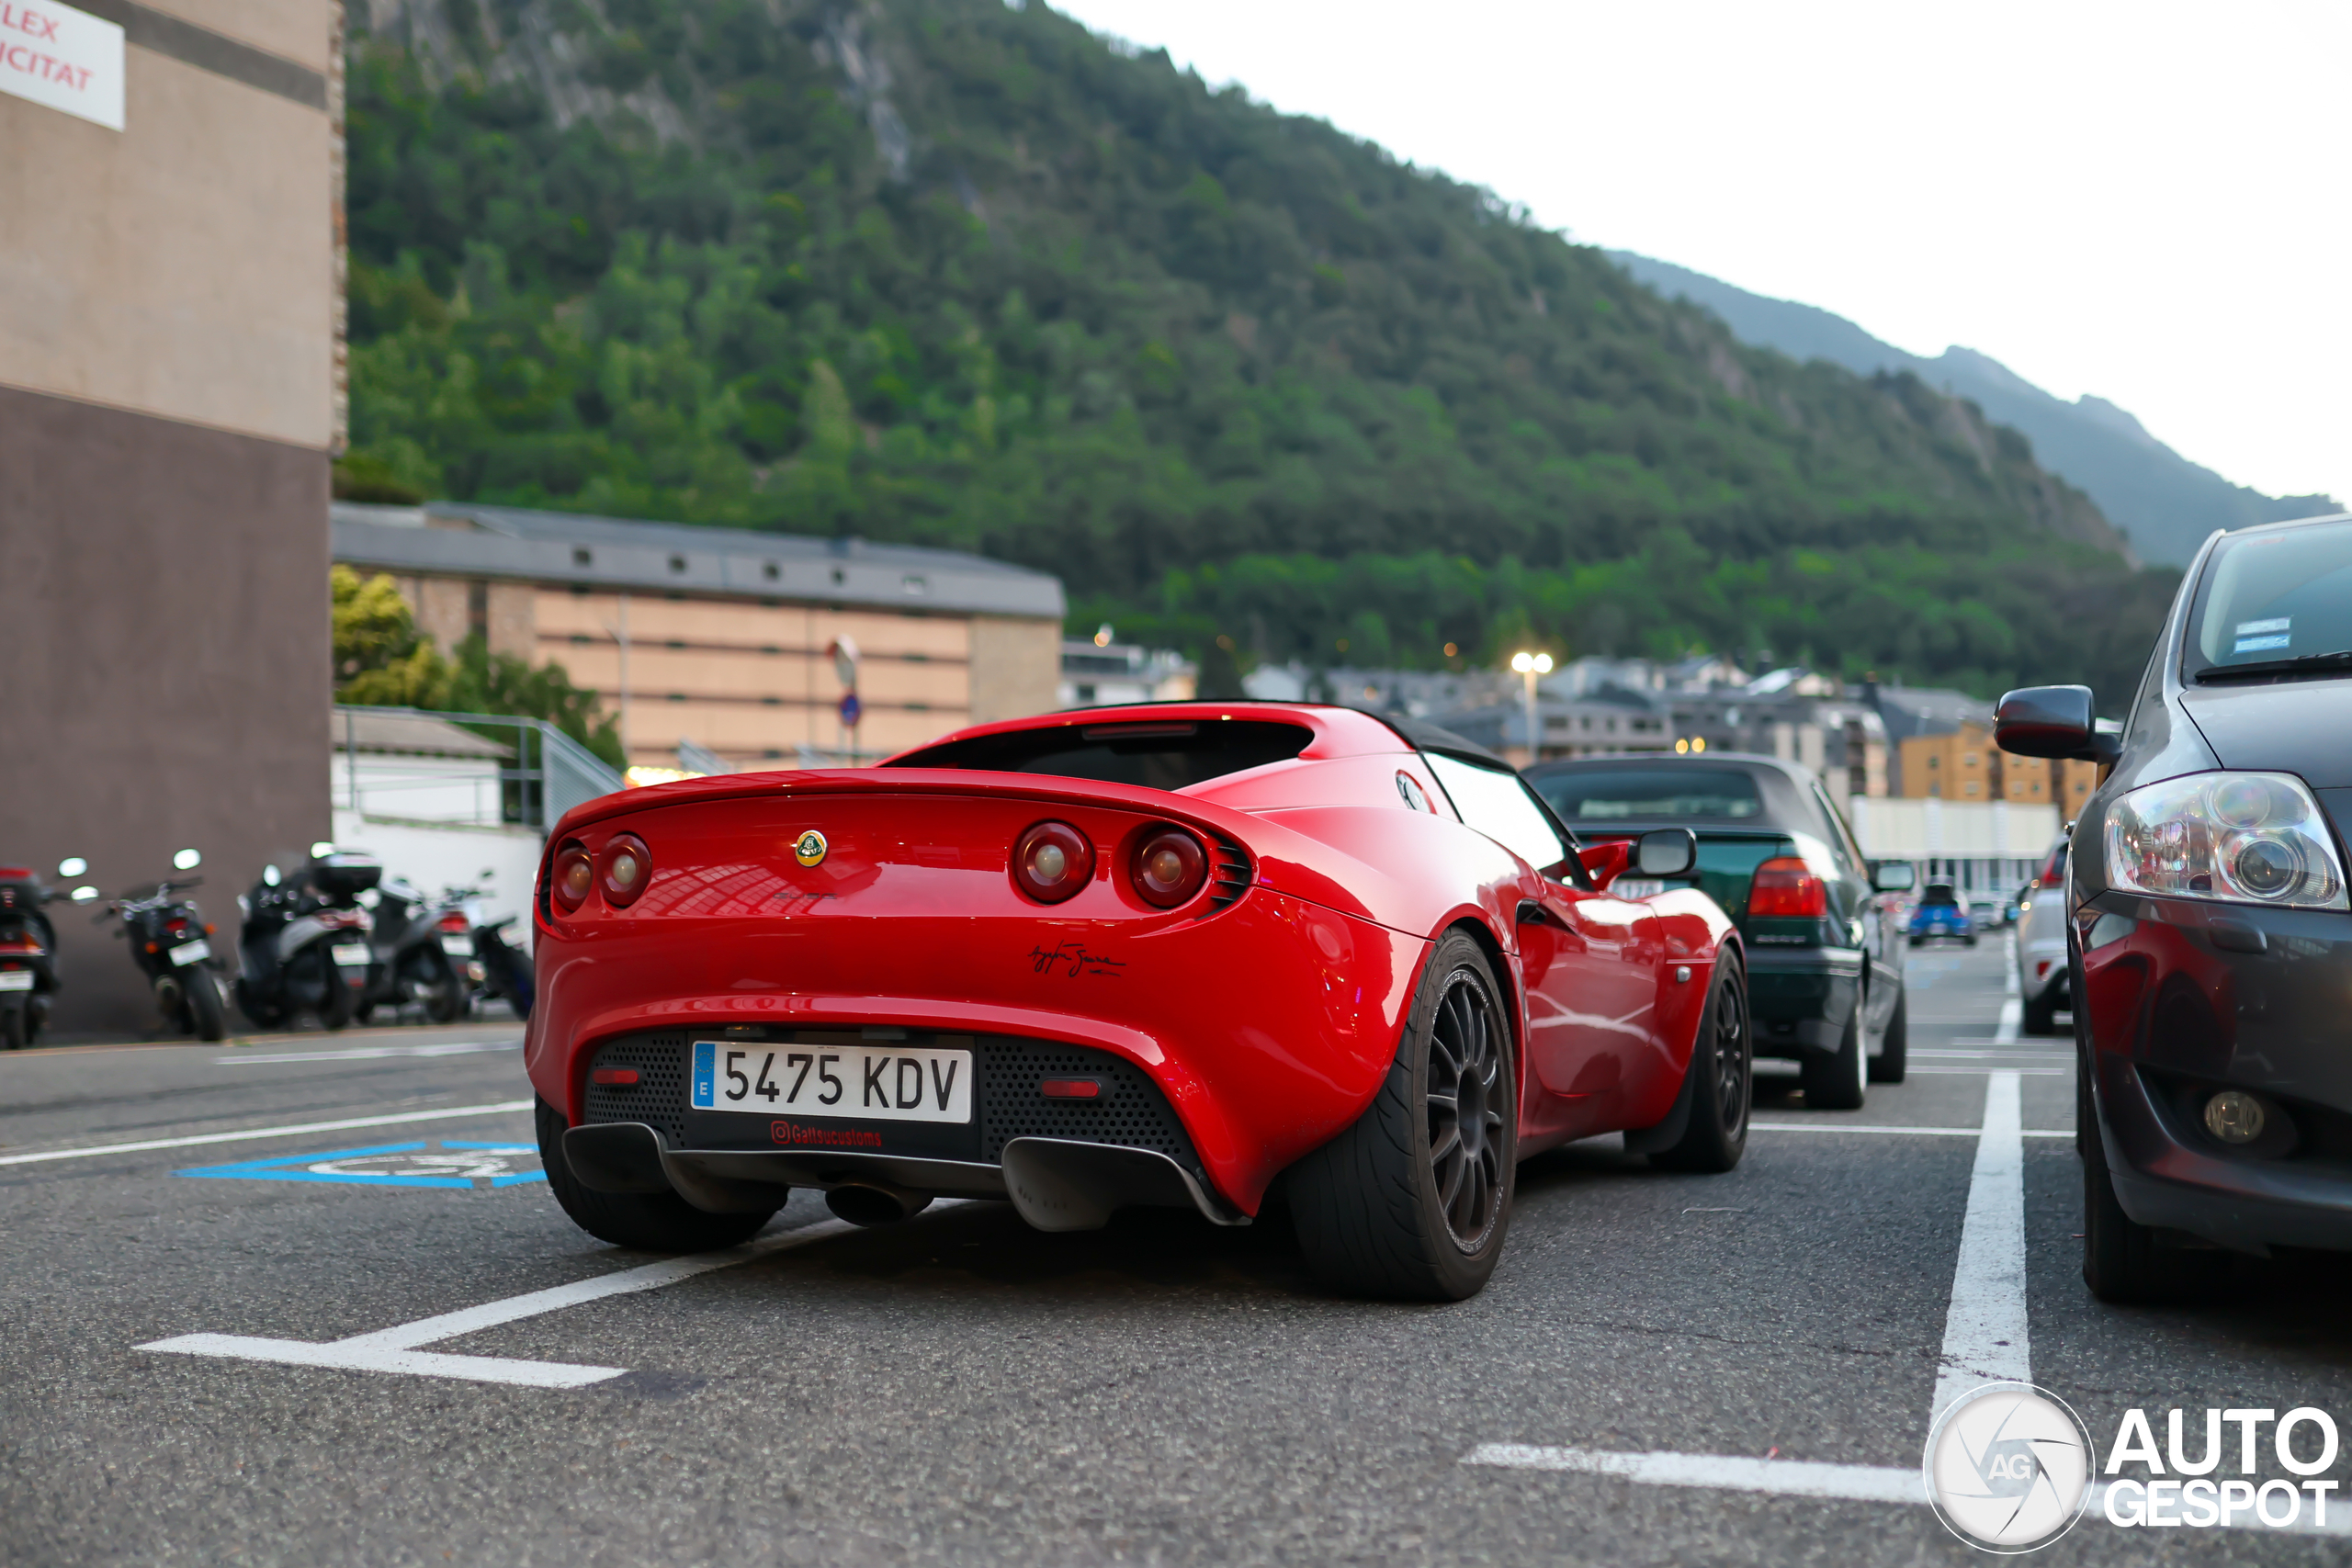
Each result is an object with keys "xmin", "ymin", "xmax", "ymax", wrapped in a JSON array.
[{"xmin": 339, "ymin": 0, "xmax": 2168, "ymax": 689}]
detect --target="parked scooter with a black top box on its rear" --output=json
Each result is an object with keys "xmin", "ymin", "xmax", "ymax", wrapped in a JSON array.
[{"xmin": 238, "ymin": 844, "xmax": 383, "ymax": 1030}]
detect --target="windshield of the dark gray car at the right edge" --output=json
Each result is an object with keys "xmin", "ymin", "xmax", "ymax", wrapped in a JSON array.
[{"xmin": 2183, "ymin": 522, "xmax": 2352, "ymax": 680}]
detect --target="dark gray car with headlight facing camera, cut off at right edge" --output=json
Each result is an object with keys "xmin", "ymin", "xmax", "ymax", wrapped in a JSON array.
[{"xmin": 1995, "ymin": 517, "xmax": 2352, "ymax": 1300}]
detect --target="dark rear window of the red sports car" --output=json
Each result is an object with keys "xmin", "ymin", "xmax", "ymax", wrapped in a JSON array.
[{"xmin": 891, "ymin": 719, "xmax": 1315, "ymax": 790}]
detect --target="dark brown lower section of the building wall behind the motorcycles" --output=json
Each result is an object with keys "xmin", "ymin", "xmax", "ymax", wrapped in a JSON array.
[{"xmin": 0, "ymin": 388, "xmax": 332, "ymax": 1032}]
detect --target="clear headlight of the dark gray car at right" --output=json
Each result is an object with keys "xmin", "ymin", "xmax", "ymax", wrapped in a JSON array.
[{"xmin": 2108, "ymin": 773, "xmax": 2347, "ymax": 909}]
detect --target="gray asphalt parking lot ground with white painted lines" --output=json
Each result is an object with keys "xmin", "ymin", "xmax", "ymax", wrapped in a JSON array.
[{"xmin": 0, "ymin": 942, "xmax": 2352, "ymax": 1563}]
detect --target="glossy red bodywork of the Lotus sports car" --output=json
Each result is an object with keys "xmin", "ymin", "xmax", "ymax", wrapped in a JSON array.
[{"xmin": 525, "ymin": 703, "xmax": 1736, "ymax": 1213}]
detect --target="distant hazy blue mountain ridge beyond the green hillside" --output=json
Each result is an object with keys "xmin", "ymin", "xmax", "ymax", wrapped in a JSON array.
[{"xmin": 1609, "ymin": 252, "xmax": 2343, "ymax": 567}]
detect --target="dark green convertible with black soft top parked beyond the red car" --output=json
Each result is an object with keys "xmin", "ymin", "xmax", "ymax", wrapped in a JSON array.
[{"xmin": 1526, "ymin": 752, "xmax": 1915, "ymax": 1110}]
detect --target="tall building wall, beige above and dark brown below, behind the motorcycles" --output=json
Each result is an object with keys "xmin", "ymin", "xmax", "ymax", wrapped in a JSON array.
[{"xmin": 0, "ymin": 17, "xmax": 339, "ymax": 1034}]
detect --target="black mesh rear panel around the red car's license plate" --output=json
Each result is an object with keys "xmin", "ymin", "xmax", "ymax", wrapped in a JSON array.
[{"xmin": 581, "ymin": 1030, "xmax": 1200, "ymax": 1170}]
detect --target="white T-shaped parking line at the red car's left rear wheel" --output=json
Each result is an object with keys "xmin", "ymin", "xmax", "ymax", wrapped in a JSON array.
[{"xmin": 139, "ymin": 1220, "xmax": 854, "ymax": 1389}]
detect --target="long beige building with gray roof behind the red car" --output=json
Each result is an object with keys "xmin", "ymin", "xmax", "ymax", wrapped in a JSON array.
[{"xmin": 334, "ymin": 503, "xmax": 1063, "ymax": 766}]
